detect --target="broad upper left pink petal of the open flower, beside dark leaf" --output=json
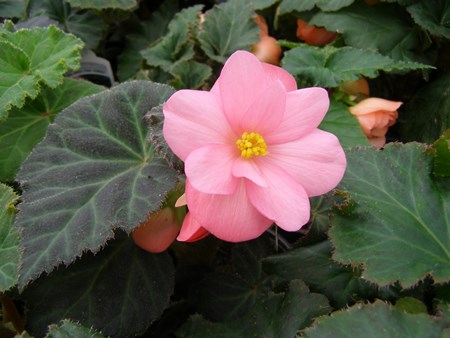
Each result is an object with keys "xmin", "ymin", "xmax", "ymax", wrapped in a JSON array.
[{"xmin": 163, "ymin": 90, "xmax": 236, "ymax": 161}]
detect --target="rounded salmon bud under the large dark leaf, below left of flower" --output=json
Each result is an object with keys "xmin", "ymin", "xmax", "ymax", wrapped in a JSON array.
[{"xmin": 132, "ymin": 207, "xmax": 180, "ymax": 253}]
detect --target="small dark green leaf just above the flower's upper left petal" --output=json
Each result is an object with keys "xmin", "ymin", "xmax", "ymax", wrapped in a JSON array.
[{"xmin": 170, "ymin": 61, "xmax": 212, "ymax": 89}]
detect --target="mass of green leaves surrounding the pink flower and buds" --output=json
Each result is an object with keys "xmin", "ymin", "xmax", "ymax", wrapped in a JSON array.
[{"xmin": 0, "ymin": 0, "xmax": 450, "ymax": 338}]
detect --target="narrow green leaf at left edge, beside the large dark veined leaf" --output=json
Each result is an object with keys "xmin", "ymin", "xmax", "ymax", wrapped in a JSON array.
[{"xmin": 0, "ymin": 183, "xmax": 20, "ymax": 292}]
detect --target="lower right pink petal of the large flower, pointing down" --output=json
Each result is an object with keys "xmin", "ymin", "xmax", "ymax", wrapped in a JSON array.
[{"xmin": 246, "ymin": 164, "xmax": 310, "ymax": 231}]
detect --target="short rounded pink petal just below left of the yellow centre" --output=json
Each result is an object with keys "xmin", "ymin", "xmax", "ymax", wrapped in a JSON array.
[{"xmin": 185, "ymin": 144, "xmax": 239, "ymax": 195}]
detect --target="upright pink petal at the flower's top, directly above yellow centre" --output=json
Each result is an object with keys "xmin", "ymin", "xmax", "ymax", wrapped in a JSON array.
[{"xmin": 219, "ymin": 51, "xmax": 268, "ymax": 133}]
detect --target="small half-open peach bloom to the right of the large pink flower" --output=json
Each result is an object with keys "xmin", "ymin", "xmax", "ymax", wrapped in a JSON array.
[{"xmin": 349, "ymin": 97, "xmax": 403, "ymax": 148}]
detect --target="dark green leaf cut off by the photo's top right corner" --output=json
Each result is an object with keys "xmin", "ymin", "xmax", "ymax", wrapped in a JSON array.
[{"xmin": 407, "ymin": 0, "xmax": 450, "ymax": 39}]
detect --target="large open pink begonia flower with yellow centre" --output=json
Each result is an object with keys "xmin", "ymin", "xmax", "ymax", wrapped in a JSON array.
[{"xmin": 163, "ymin": 51, "xmax": 346, "ymax": 242}]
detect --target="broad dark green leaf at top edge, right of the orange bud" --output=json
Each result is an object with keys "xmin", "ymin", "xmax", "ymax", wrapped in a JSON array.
[{"xmin": 309, "ymin": 1, "xmax": 426, "ymax": 61}]
